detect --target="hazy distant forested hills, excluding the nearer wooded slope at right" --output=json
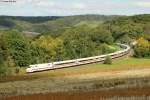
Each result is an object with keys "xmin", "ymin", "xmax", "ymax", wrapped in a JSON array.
[{"xmin": 0, "ymin": 15, "xmax": 117, "ymax": 33}]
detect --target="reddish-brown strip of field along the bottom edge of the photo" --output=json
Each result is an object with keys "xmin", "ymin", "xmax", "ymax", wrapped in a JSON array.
[{"xmin": 1, "ymin": 88, "xmax": 150, "ymax": 100}]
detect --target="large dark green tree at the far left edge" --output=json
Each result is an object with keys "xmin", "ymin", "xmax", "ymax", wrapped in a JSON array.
[{"xmin": 0, "ymin": 30, "xmax": 31, "ymax": 66}]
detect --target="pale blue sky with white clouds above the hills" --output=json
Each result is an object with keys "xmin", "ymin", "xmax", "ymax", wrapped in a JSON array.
[{"xmin": 0, "ymin": 0, "xmax": 150, "ymax": 16}]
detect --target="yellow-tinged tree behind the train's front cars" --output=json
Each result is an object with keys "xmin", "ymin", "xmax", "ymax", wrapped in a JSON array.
[{"xmin": 31, "ymin": 35, "xmax": 65, "ymax": 63}]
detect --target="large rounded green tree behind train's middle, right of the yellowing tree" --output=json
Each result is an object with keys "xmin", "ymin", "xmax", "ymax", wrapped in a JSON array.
[{"xmin": 63, "ymin": 26, "xmax": 95, "ymax": 59}]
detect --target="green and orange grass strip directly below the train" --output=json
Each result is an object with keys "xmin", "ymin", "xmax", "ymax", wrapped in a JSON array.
[{"xmin": 30, "ymin": 58, "xmax": 150, "ymax": 76}]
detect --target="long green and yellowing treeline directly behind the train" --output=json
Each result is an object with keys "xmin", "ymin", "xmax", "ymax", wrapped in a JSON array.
[{"xmin": 0, "ymin": 26, "xmax": 116, "ymax": 66}]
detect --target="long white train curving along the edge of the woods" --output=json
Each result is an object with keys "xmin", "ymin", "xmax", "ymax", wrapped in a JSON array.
[{"xmin": 26, "ymin": 43, "xmax": 130, "ymax": 73}]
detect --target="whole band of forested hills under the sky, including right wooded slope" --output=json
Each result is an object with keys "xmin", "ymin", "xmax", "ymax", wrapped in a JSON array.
[{"xmin": 0, "ymin": 14, "xmax": 150, "ymax": 41}]
